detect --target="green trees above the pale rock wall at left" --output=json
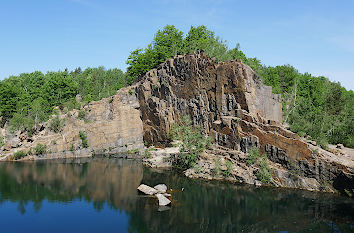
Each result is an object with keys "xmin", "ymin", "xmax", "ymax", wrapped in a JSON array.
[{"xmin": 0, "ymin": 67, "xmax": 131, "ymax": 134}]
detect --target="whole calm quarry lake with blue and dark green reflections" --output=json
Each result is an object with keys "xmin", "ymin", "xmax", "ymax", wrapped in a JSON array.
[{"xmin": 0, "ymin": 158, "xmax": 354, "ymax": 233}]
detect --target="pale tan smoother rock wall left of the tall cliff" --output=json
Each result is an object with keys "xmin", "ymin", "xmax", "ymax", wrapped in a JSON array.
[{"xmin": 0, "ymin": 87, "xmax": 144, "ymax": 160}]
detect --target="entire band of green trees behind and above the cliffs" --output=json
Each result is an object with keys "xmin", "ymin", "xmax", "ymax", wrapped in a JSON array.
[{"xmin": 0, "ymin": 25, "xmax": 354, "ymax": 147}]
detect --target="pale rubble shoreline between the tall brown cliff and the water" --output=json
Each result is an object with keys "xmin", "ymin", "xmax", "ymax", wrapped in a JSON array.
[{"xmin": 143, "ymin": 147, "xmax": 352, "ymax": 193}]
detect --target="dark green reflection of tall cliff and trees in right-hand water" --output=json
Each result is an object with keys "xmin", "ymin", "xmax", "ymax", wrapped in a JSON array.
[{"xmin": 130, "ymin": 170, "xmax": 354, "ymax": 232}]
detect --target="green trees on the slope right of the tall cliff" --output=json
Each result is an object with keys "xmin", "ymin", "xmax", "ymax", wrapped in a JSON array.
[{"xmin": 260, "ymin": 65, "xmax": 354, "ymax": 149}]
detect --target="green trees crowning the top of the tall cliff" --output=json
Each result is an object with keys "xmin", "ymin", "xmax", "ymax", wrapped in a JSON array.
[{"xmin": 126, "ymin": 25, "xmax": 262, "ymax": 79}]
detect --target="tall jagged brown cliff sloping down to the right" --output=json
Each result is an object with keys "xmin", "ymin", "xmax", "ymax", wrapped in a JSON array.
[{"xmin": 136, "ymin": 53, "xmax": 354, "ymax": 193}]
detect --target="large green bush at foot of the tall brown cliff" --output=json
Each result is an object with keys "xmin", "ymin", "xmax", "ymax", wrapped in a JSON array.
[{"xmin": 170, "ymin": 116, "xmax": 211, "ymax": 168}]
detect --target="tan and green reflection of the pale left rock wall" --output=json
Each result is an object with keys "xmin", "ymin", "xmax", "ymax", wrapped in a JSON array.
[{"xmin": 0, "ymin": 158, "xmax": 143, "ymax": 210}]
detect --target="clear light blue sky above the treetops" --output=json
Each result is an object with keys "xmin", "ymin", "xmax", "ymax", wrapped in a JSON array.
[{"xmin": 0, "ymin": 0, "xmax": 354, "ymax": 90}]
